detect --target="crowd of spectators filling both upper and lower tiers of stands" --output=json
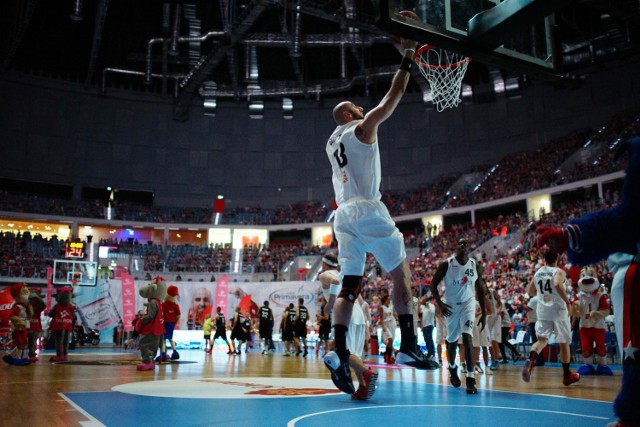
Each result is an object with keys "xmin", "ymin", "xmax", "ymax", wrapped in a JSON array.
[{"xmin": 0, "ymin": 112, "xmax": 640, "ymax": 342}]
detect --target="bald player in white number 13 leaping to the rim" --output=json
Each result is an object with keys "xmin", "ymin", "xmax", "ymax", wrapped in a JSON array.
[{"xmin": 325, "ymin": 12, "xmax": 437, "ymax": 393}]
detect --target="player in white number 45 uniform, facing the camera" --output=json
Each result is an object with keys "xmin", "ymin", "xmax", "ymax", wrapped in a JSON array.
[{"xmin": 430, "ymin": 238, "xmax": 486, "ymax": 394}]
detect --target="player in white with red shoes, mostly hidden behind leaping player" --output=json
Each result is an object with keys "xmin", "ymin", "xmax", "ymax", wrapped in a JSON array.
[{"xmin": 318, "ymin": 253, "xmax": 378, "ymax": 400}]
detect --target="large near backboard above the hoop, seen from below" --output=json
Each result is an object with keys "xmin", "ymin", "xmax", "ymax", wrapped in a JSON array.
[{"xmin": 376, "ymin": 0, "xmax": 568, "ymax": 81}]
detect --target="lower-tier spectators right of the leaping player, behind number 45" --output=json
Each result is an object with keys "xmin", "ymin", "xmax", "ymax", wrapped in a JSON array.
[{"xmin": 362, "ymin": 198, "xmax": 616, "ymax": 335}]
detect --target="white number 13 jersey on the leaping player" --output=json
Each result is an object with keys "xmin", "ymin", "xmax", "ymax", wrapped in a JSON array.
[{"xmin": 326, "ymin": 120, "xmax": 381, "ymax": 206}]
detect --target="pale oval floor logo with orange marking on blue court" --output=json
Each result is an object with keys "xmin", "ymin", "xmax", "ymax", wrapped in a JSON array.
[{"xmin": 113, "ymin": 377, "xmax": 340, "ymax": 399}]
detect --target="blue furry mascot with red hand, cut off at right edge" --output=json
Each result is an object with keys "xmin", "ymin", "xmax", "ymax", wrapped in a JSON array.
[{"xmin": 538, "ymin": 137, "xmax": 640, "ymax": 427}]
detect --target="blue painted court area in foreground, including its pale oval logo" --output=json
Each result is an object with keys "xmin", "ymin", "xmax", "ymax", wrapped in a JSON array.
[{"xmin": 63, "ymin": 377, "xmax": 613, "ymax": 427}]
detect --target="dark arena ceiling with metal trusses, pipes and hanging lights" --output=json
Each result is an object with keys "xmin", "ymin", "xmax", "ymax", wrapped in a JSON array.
[{"xmin": 0, "ymin": 0, "xmax": 640, "ymax": 120}]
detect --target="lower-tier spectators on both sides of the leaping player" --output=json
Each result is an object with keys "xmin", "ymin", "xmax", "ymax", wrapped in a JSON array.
[{"xmin": 0, "ymin": 197, "xmax": 616, "ymax": 342}]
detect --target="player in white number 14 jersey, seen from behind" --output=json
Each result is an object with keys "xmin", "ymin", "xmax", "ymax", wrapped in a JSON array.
[{"xmin": 522, "ymin": 251, "xmax": 580, "ymax": 385}]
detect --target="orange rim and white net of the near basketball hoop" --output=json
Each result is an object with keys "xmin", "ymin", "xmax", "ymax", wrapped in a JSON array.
[{"xmin": 414, "ymin": 44, "xmax": 471, "ymax": 112}]
